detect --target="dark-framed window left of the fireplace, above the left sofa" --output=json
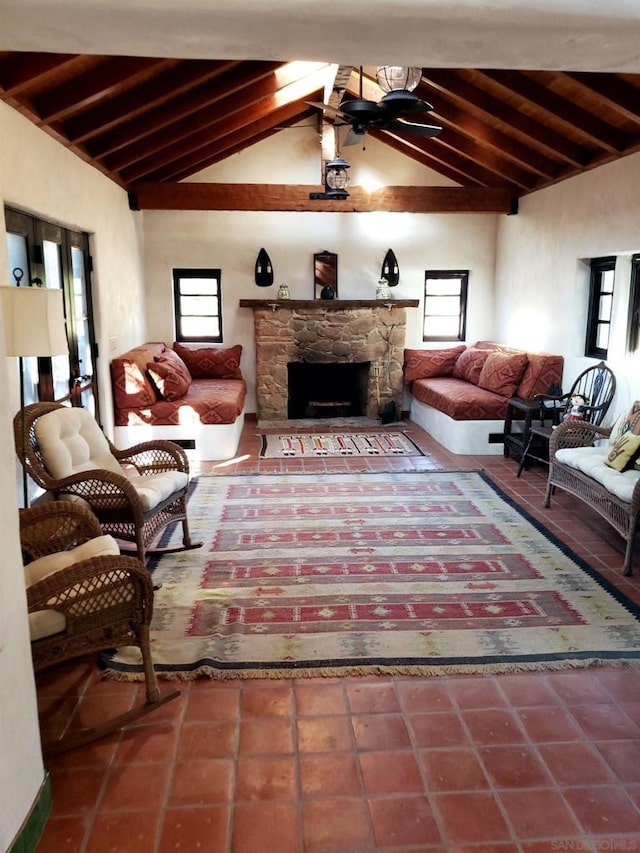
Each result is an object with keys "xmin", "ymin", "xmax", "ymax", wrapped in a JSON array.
[{"xmin": 173, "ymin": 269, "xmax": 222, "ymax": 342}]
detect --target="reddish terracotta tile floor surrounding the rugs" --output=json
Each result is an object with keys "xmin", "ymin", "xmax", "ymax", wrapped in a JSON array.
[{"xmin": 33, "ymin": 422, "xmax": 640, "ymax": 853}]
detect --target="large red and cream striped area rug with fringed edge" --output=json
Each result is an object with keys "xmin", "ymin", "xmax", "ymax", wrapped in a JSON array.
[{"xmin": 105, "ymin": 472, "xmax": 640, "ymax": 679}]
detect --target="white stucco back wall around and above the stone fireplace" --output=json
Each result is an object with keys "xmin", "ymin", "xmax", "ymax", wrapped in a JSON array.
[{"xmin": 144, "ymin": 127, "xmax": 498, "ymax": 412}]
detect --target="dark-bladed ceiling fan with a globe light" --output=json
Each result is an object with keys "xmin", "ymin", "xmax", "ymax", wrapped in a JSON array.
[{"xmin": 311, "ymin": 65, "xmax": 442, "ymax": 145}]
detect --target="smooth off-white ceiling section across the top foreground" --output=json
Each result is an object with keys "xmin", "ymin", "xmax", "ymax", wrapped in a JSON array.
[{"xmin": 0, "ymin": 0, "xmax": 640, "ymax": 73}]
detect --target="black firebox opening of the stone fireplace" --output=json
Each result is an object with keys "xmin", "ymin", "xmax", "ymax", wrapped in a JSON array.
[{"xmin": 287, "ymin": 361, "xmax": 371, "ymax": 419}]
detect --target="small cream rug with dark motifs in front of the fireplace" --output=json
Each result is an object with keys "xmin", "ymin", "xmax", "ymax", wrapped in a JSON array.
[{"xmin": 260, "ymin": 432, "xmax": 425, "ymax": 459}]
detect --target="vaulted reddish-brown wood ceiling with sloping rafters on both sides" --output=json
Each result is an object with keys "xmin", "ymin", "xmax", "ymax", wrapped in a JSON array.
[{"xmin": 0, "ymin": 52, "xmax": 640, "ymax": 206}]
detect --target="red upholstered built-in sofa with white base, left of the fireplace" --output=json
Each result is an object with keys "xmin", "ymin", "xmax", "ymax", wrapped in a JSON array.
[{"xmin": 111, "ymin": 341, "xmax": 247, "ymax": 459}]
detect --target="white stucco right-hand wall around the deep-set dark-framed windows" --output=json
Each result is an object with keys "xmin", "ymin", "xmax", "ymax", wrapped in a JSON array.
[{"xmin": 494, "ymin": 154, "xmax": 640, "ymax": 416}]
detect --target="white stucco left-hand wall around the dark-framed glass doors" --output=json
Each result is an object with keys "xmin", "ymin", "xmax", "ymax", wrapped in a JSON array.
[{"xmin": 0, "ymin": 98, "xmax": 146, "ymax": 850}]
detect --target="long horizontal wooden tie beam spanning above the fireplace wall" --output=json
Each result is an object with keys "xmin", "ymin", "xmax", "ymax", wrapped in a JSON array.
[{"xmin": 131, "ymin": 183, "xmax": 514, "ymax": 213}]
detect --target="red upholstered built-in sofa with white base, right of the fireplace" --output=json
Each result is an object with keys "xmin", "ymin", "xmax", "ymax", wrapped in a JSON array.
[{"xmin": 404, "ymin": 341, "xmax": 564, "ymax": 455}]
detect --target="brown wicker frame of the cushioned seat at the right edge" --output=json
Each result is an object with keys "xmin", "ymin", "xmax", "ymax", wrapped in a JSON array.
[{"xmin": 544, "ymin": 421, "xmax": 640, "ymax": 576}]
